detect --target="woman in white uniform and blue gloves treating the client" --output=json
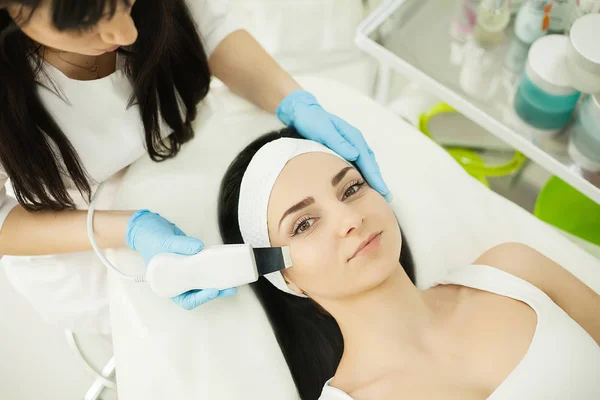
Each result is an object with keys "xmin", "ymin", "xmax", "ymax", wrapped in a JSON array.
[{"xmin": 0, "ymin": 0, "xmax": 389, "ymax": 320}]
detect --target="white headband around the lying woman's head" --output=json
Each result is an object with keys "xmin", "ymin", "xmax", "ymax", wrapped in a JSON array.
[{"xmin": 238, "ymin": 138, "xmax": 343, "ymax": 297}]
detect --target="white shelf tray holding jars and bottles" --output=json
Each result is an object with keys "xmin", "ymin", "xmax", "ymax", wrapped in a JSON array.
[{"xmin": 356, "ymin": 0, "xmax": 600, "ymax": 204}]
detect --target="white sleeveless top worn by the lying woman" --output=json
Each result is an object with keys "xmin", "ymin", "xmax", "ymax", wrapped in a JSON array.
[{"xmin": 319, "ymin": 265, "xmax": 600, "ymax": 400}]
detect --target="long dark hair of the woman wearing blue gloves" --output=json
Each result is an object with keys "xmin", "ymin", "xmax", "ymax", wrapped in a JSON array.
[{"xmin": 0, "ymin": 0, "xmax": 210, "ymax": 211}]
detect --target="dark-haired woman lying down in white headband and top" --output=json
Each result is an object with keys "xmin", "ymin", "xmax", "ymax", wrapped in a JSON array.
[{"xmin": 219, "ymin": 129, "xmax": 600, "ymax": 400}]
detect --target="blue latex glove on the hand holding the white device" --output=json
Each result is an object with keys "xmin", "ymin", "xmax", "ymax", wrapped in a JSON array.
[{"xmin": 125, "ymin": 210, "xmax": 237, "ymax": 310}]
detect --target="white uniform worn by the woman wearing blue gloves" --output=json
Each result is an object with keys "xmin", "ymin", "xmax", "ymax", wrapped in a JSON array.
[{"xmin": 0, "ymin": 0, "xmax": 240, "ymax": 333}]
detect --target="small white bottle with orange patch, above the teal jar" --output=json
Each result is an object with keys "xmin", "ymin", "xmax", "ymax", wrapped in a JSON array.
[{"xmin": 515, "ymin": 0, "xmax": 552, "ymax": 44}]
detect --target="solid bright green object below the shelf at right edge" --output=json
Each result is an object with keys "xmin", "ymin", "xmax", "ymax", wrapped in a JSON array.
[{"xmin": 534, "ymin": 176, "xmax": 600, "ymax": 246}]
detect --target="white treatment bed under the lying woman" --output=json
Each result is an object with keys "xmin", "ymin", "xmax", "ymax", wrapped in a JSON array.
[{"xmin": 110, "ymin": 78, "xmax": 600, "ymax": 400}]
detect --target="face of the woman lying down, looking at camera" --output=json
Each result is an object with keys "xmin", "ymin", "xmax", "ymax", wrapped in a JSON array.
[{"xmin": 267, "ymin": 153, "xmax": 401, "ymax": 301}]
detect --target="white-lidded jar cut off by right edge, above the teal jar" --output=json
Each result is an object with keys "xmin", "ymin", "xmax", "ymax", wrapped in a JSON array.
[{"xmin": 567, "ymin": 14, "xmax": 600, "ymax": 94}]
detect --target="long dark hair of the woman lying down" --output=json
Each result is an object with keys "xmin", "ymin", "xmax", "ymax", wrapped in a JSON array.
[{"xmin": 218, "ymin": 128, "xmax": 415, "ymax": 400}]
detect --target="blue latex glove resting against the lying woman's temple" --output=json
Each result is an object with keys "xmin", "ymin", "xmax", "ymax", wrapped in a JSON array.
[{"xmin": 276, "ymin": 90, "xmax": 392, "ymax": 202}]
